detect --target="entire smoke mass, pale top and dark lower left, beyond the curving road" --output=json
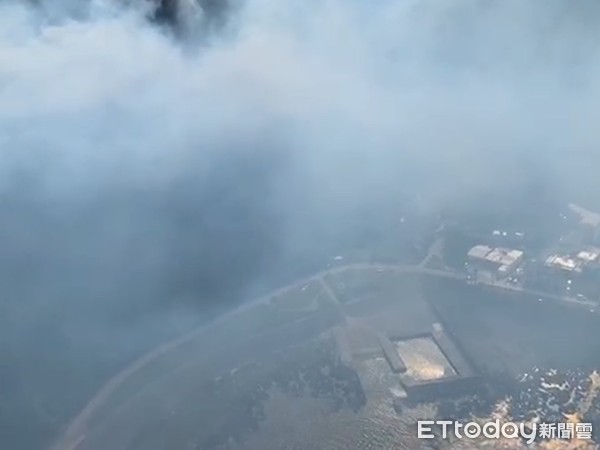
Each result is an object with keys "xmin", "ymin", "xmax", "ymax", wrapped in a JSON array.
[{"xmin": 0, "ymin": 0, "xmax": 600, "ymax": 450}]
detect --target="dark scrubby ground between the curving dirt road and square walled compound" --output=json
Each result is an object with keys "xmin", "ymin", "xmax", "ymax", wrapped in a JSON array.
[{"xmin": 75, "ymin": 340, "xmax": 366, "ymax": 450}]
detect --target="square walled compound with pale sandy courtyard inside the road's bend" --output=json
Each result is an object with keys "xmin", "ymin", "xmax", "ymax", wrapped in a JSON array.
[{"xmin": 344, "ymin": 322, "xmax": 478, "ymax": 411}]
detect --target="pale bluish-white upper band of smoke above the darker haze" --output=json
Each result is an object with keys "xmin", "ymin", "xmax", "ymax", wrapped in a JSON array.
[{"xmin": 0, "ymin": 0, "xmax": 598, "ymax": 206}]
